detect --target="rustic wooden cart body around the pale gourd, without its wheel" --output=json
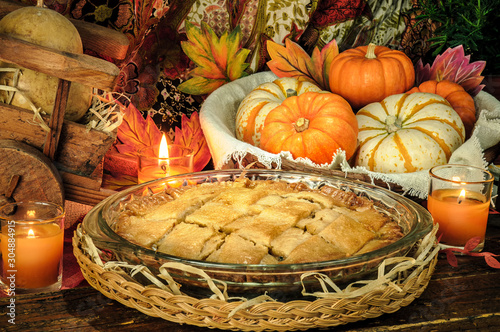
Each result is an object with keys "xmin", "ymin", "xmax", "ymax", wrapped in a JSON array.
[{"xmin": 0, "ymin": 0, "xmax": 129, "ymax": 204}]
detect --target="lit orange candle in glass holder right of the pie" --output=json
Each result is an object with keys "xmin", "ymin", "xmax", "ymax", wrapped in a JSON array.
[{"xmin": 427, "ymin": 164, "xmax": 494, "ymax": 252}]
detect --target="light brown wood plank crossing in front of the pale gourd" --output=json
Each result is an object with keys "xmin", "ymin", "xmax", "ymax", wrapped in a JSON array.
[{"xmin": 0, "ymin": 34, "xmax": 120, "ymax": 91}]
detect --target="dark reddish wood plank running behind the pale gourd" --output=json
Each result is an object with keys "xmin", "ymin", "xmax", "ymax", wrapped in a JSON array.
[{"xmin": 0, "ymin": 0, "xmax": 130, "ymax": 60}]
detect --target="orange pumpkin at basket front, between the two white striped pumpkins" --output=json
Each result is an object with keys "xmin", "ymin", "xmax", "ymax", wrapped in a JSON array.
[{"xmin": 260, "ymin": 92, "xmax": 358, "ymax": 165}]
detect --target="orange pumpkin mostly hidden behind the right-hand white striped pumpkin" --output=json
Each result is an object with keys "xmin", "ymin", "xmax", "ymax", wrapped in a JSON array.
[{"xmin": 408, "ymin": 80, "xmax": 476, "ymax": 137}]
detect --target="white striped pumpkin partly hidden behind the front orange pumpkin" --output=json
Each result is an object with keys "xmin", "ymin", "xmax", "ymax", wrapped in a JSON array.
[{"xmin": 236, "ymin": 77, "xmax": 321, "ymax": 146}]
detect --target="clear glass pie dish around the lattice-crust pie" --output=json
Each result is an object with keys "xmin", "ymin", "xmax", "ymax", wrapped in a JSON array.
[{"xmin": 83, "ymin": 169, "xmax": 433, "ymax": 298}]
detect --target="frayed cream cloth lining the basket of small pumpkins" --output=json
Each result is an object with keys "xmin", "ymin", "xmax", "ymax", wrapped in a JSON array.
[{"xmin": 200, "ymin": 72, "xmax": 500, "ymax": 198}]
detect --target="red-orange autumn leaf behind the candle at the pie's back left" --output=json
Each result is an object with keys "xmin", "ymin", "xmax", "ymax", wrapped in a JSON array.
[{"xmin": 115, "ymin": 104, "xmax": 212, "ymax": 172}]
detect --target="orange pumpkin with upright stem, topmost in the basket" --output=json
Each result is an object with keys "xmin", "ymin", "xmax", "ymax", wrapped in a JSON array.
[{"xmin": 329, "ymin": 44, "xmax": 415, "ymax": 110}]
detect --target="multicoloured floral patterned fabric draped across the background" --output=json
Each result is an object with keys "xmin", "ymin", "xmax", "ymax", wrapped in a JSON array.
[{"xmin": 14, "ymin": 0, "xmax": 415, "ymax": 141}]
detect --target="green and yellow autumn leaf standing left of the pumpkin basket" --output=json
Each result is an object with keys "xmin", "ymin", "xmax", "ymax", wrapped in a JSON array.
[{"xmin": 178, "ymin": 21, "xmax": 250, "ymax": 95}]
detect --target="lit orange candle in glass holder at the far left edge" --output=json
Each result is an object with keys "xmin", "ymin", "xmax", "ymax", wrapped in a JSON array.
[{"xmin": 0, "ymin": 202, "xmax": 64, "ymax": 296}]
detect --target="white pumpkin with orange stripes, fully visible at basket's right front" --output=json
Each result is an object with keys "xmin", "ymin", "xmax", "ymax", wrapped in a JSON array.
[{"xmin": 355, "ymin": 93, "xmax": 465, "ymax": 173}]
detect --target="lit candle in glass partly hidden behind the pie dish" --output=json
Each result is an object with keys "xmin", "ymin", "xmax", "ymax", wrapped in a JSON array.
[{"xmin": 137, "ymin": 144, "xmax": 194, "ymax": 183}]
